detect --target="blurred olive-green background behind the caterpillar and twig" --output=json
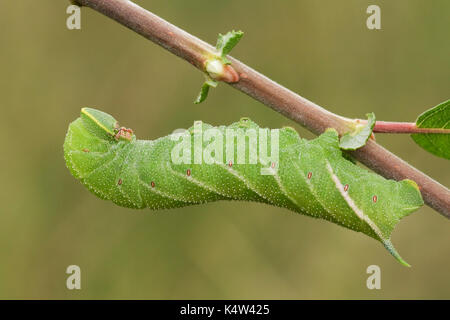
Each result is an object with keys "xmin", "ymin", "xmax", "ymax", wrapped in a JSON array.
[{"xmin": 0, "ymin": 0, "xmax": 450, "ymax": 299}]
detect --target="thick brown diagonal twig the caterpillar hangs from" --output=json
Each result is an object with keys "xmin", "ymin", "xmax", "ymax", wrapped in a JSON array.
[{"xmin": 72, "ymin": 0, "xmax": 450, "ymax": 218}]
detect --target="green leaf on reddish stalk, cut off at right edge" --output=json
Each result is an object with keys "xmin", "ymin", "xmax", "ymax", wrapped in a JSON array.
[{"xmin": 411, "ymin": 100, "xmax": 450, "ymax": 160}]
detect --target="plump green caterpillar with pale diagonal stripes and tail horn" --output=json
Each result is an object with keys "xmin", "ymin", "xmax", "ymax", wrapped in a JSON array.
[{"xmin": 64, "ymin": 108, "xmax": 423, "ymax": 266}]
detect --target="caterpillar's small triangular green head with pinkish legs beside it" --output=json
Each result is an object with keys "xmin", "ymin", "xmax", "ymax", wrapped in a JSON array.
[{"xmin": 81, "ymin": 108, "xmax": 134, "ymax": 141}]
